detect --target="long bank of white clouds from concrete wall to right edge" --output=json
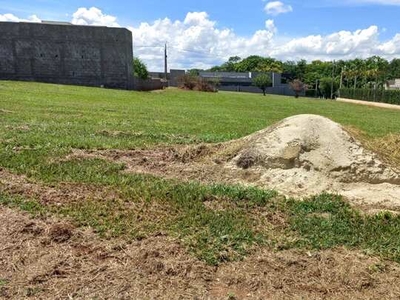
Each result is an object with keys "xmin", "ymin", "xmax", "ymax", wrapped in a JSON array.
[{"xmin": 129, "ymin": 12, "xmax": 400, "ymax": 70}]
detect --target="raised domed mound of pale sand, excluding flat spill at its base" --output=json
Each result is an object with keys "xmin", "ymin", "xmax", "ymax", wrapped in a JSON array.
[{"xmin": 232, "ymin": 115, "xmax": 400, "ymax": 184}]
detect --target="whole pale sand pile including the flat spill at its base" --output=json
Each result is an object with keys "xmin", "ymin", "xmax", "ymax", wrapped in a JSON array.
[{"xmin": 225, "ymin": 115, "xmax": 400, "ymax": 206}]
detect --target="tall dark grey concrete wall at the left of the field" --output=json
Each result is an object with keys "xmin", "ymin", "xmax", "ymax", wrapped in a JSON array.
[{"xmin": 0, "ymin": 22, "xmax": 133, "ymax": 89}]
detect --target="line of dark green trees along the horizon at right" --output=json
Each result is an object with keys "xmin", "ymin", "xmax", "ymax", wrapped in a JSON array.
[{"xmin": 189, "ymin": 55, "xmax": 400, "ymax": 88}]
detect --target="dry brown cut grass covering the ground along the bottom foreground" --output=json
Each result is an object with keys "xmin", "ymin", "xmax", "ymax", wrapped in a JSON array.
[{"xmin": 0, "ymin": 207, "xmax": 400, "ymax": 299}]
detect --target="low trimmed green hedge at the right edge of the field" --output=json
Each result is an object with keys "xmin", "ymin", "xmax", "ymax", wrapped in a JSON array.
[{"xmin": 340, "ymin": 88, "xmax": 400, "ymax": 105}]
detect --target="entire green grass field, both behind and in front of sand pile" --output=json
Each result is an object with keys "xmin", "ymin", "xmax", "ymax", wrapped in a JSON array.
[{"xmin": 0, "ymin": 82, "xmax": 400, "ymax": 265}]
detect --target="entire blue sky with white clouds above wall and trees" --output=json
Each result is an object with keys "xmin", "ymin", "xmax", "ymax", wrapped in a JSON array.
[{"xmin": 0, "ymin": 0, "xmax": 400, "ymax": 71}]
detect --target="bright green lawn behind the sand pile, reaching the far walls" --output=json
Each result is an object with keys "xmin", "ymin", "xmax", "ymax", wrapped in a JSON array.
[{"xmin": 0, "ymin": 81, "xmax": 400, "ymax": 177}]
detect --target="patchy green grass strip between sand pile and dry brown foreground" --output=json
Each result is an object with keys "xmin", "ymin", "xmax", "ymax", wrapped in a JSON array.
[{"xmin": 0, "ymin": 190, "xmax": 400, "ymax": 265}]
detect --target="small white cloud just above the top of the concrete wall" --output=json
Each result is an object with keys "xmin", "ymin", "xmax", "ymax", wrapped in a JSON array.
[{"xmin": 71, "ymin": 7, "xmax": 120, "ymax": 27}]
